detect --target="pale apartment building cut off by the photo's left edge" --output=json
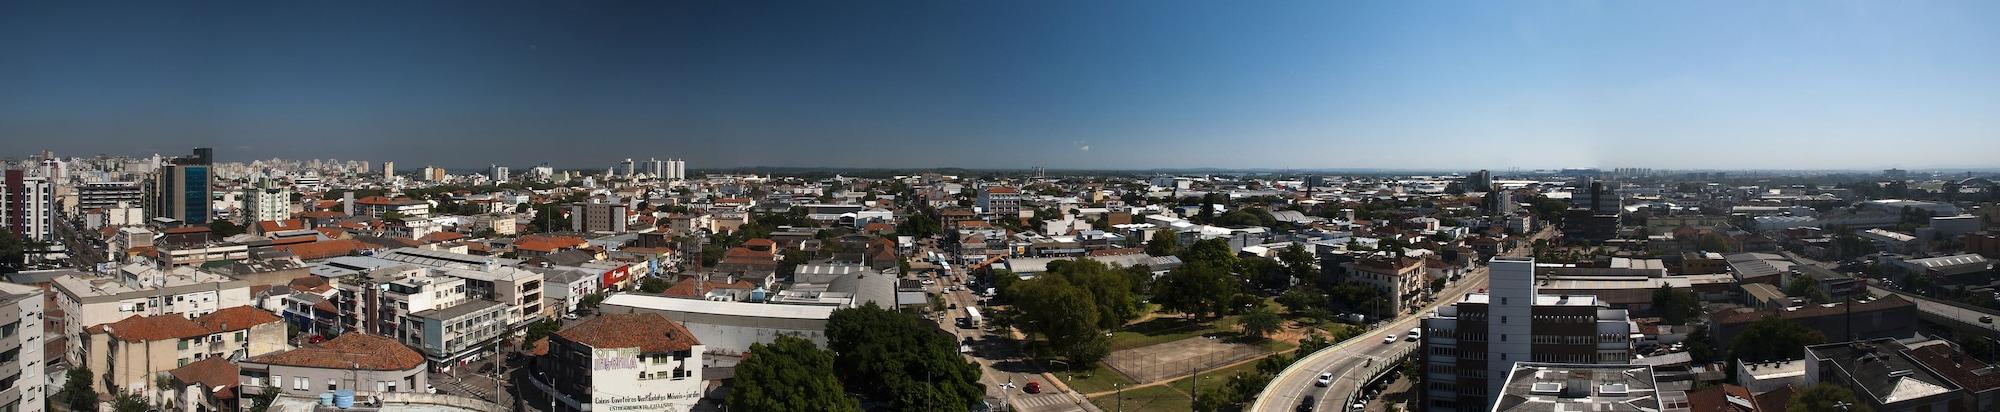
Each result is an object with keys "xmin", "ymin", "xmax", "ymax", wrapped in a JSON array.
[{"xmin": 0, "ymin": 284, "xmax": 50, "ymax": 412}]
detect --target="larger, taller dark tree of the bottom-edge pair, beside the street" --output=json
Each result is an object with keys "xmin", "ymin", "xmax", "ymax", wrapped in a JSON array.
[{"xmin": 826, "ymin": 302, "xmax": 986, "ymax": 410}]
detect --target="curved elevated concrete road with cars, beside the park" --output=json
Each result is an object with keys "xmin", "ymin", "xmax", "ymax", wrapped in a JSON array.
[{"xmin": 1248, "ymin": 230, "xmax": 1554, "ymax": 412}]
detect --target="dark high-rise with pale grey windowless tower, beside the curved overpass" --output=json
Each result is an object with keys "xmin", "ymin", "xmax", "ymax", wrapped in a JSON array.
[{"xmin": 1418, "ymin": 256, "xmax": 1634, "ymax": 412}]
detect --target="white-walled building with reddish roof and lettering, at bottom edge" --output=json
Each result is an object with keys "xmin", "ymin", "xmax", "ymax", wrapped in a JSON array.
[{"xmin": 530, "ymin": 314, "xmax": 706, "ymax": 412}]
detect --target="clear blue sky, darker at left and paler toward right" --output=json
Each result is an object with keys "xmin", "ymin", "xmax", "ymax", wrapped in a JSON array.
[{"xmin": 0, "ymin": 0, "xmax": 2000, "ymax": 170}]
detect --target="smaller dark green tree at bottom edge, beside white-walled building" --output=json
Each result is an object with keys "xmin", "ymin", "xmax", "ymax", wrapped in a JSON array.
[{"xmin": 728, "ymin": 336, "xmax": 860, "ymax": 412}]
